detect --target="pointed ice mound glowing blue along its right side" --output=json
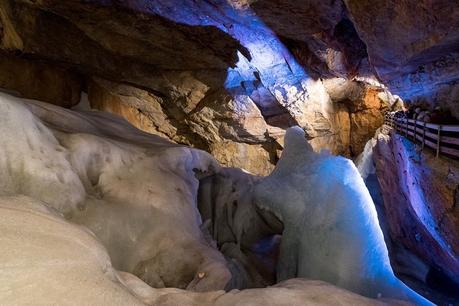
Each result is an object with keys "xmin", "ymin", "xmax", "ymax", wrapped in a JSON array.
[{"xmin": 255, "ymin": 127, "xmax": 430, "ymax": 305}]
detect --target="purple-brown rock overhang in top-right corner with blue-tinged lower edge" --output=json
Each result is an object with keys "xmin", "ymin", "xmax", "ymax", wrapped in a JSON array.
[{"xmin": 344, "ymin": 0, "xmax": 459, "ymax": 109}]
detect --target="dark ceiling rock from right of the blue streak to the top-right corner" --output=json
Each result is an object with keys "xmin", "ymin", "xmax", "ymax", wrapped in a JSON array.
[{"xmin": 239, "ymin": 0, "xmax": 459, "ymax": 111}]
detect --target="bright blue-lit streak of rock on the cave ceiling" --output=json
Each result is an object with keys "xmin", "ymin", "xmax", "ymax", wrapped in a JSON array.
[{"xmin": 132, "ymin": 0, "xmax": 310, "ymax": 115}]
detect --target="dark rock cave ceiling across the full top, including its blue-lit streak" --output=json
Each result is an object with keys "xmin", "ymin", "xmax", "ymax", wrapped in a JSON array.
[{"xmin": 0, "ymin": 0, "xmax": 459, "ymax": 98}]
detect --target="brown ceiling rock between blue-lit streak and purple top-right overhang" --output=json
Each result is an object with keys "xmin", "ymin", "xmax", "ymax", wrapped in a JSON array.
[{"xmin": 246, "ymin": 0, "xmax": 367, "ymax": 78}]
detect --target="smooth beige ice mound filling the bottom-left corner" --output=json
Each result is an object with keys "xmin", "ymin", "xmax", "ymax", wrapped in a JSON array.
[{"xmin": 0, "ymin": 196, "xmax": 142, "ymax": 305}]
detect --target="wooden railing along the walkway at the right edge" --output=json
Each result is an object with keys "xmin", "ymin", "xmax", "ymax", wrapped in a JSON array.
[{"xmin": 384, "ymin": 113, "xmax": 459, "ymax": 158}]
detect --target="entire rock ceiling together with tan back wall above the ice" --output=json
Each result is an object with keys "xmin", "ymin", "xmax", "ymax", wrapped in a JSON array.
[{"xmin": 0, "ymin": 0, "xmax": 459, "ymax": 174}]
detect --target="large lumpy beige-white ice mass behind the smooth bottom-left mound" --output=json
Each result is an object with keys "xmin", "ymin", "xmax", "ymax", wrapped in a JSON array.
[{"xmin": 0, "ymin": 94, "xmax": 231, "ymax": 291}]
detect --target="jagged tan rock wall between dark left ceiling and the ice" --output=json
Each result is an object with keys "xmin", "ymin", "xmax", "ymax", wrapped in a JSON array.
[{"xmin": 88, "ymin": 79, "xmax": 283, "ymax": 174}]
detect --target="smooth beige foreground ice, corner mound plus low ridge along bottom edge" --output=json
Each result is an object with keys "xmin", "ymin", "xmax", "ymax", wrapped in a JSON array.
[{"xmin": 0, "ymin": 196, "xmax": 406, "ymax": 306}]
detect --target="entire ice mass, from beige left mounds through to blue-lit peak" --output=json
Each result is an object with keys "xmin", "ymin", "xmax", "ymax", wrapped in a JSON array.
[{"xmin": 0, "ymin": 94, "xmax": 427, "ymax": 306}]
